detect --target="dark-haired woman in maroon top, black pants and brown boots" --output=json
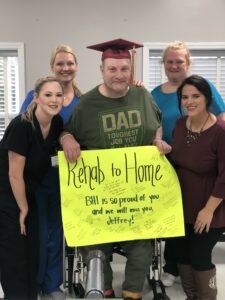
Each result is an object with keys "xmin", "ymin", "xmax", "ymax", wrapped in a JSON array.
[{"xmin": 170, "ymin": 75, "xmax": 225, "ymax": 299}]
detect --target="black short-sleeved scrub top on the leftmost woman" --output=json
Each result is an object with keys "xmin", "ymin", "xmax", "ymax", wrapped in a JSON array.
[{"xmin": 0, "ymin": 113, "xmax": 63, "ymax": 207}]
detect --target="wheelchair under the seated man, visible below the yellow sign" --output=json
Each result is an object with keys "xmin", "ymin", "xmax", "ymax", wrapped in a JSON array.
[{"xmin": 63, "ymin": 239, "xmax": 170, "ymax": 300}]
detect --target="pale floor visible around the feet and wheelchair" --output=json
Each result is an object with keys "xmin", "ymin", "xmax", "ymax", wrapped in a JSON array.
[{"xmin": 0, "ymin": 242, "xmax": 225, "ymax": 300}]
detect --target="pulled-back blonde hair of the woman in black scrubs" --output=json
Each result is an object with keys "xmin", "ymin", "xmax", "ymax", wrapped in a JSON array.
[{"xmin": 21, "ymin": 76, "xmax": 63, "ymax": 128}]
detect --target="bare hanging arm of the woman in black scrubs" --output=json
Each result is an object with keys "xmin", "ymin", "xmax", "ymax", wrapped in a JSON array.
[{"xmin": 8, "ymin": 151, "xmax": 28, "ymax": 235}]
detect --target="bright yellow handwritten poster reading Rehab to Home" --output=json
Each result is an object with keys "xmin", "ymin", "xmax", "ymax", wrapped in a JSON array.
[{"xmin": 58, "ymin": 146, "xmax": 184, "ymax": 246}]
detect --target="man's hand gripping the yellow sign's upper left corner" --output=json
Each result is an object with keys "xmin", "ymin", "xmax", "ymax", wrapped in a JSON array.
[{"xmin": 61, "ymin": 133, "xmax": 80, "ymax": 163}]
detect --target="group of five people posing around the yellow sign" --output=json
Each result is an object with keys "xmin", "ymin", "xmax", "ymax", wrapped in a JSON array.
[{"xmin": 0, "ymin": 39, "xmax": 225, "ymax": 300}]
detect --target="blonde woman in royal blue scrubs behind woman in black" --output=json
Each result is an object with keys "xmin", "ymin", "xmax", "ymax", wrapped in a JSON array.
[{"xmin": 18, "ymin": 44, "xmax": 81, "ymax": 299}]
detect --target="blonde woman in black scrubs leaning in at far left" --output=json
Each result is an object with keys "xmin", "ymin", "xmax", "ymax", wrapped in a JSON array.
[{"xmin": 0, "ymin": 77, "xmax": 64, "ymax": 300}]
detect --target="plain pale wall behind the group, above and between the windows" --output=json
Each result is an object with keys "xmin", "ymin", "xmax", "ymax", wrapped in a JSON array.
[{"xmin": 0, "ymin": 0, "xmax": 225, "ymax": 101}]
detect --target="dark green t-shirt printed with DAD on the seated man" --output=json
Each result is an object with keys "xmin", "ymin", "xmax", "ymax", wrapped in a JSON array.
[{"xmin": 66, "ymin": 86, "xmax": 161, "ymax": 149}]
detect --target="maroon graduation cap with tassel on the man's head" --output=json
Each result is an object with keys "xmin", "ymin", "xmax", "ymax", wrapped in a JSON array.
[{"xmin": 87, "ymin": 39, "xmax": 143, "ymax": 82}]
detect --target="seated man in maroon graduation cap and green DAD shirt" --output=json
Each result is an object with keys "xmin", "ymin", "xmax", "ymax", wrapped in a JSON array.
[{"xmin": 61, "ymin": 39, "xmax": 171, "ymax": 300}]
